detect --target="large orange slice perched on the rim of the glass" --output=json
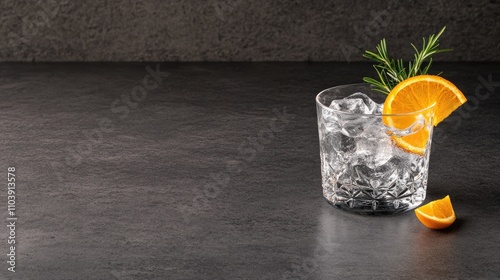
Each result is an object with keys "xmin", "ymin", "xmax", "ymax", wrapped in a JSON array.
[{"xmin": 382, "ymin": 75, "xmax": 467, "ymax": 155}]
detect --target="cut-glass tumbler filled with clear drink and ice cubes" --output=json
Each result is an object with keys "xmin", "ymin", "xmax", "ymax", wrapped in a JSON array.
[{"xmin": 316, "ymin": 84, "xmax": 434, "ymax": 214}]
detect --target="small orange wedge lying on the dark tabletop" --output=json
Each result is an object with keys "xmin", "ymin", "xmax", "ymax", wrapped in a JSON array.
[{"xmin": 415, "ymin": 195, "xmax": 457, "ymax": 229}]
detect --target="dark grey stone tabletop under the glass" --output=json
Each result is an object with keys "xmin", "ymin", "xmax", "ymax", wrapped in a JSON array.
[{"xmin": 0, "ymin": 63, "xmax": 500, "ymax": 279}]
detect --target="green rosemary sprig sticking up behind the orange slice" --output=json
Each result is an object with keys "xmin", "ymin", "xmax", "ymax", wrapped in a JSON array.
[{"xmin": 363, "ymin": 26, "xmax": 452, "ymax": 94}]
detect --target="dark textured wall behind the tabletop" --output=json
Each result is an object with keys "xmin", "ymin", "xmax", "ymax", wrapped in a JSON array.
[{"xmin": 0, "ymin": 0, "xmax": 500, "ymax": 61}]
